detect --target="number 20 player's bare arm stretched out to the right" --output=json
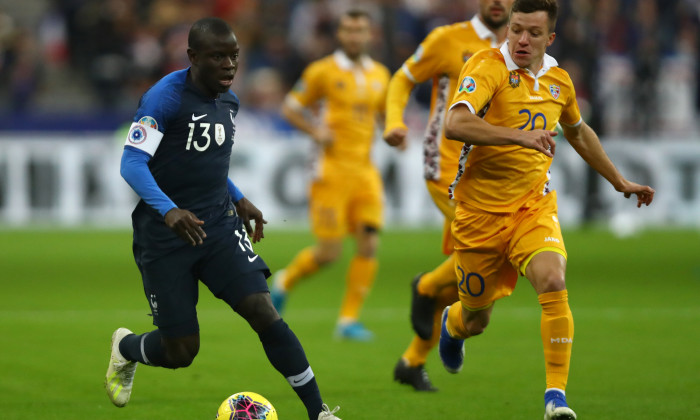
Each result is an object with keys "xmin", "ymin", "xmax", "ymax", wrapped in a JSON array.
[{"xmin": 562, "ymin": 122, "xmax": 655, "ymax": 207}]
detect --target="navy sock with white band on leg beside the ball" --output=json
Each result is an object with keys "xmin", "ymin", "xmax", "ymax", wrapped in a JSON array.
[{"xmin": 258, "ymin": 319, "xmax": 323, "ymax": 420}]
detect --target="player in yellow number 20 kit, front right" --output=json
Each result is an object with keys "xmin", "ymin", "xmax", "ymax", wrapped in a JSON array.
[{"xmin": 439, "ymin": 0, "xmax": 654, "ymax": 420}]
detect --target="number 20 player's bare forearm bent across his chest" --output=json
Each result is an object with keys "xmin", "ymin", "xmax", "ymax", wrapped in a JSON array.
[{"xmin": 445, "ymin": 102, "xmax": 557, "ymax": 157}]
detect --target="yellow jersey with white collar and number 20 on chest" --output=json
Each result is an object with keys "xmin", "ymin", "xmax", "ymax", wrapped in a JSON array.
[{"xmin": 450, "ymin": 42, "xmax": 582, "ymax": 213}]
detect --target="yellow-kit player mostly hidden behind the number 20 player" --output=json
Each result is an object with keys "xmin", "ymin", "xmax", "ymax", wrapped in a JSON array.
[{"xmin": 384, "ymin": 0, "xmax": 513, "ymax": 391}]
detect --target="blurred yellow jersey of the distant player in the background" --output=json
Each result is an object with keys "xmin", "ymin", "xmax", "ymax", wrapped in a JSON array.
[{"xmin": 287, "ymin": 50, "xmax": 390, "ymax": 175}]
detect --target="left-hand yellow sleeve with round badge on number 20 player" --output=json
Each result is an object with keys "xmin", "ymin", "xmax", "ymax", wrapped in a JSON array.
[{"xmin": 450, "ymin": 50, "xmax": 505, "ymax": 114}]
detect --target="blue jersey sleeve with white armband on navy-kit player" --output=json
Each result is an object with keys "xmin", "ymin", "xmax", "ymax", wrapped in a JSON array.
[{"xmin": 124, "ymin": 80, "xmax": 180, "ymax": 156}]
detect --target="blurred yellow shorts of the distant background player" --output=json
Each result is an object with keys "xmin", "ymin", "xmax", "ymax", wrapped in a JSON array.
[{"xmin": 309, "ymin": 168, "xmax": 384, "ymax": 239}]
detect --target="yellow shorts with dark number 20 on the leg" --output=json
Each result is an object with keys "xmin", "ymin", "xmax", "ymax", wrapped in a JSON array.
[{"xmin": 452, "ymin": 191, "xmax": 566, "ymax": 310}]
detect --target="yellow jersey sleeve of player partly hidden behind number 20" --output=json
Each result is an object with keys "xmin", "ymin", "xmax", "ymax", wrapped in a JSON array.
[{"xmin": 401, "ymin": 27, "xmax": 452, "ymax": 84}]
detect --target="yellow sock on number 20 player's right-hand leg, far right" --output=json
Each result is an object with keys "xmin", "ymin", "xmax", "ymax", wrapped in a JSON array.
[{"xmin": 537, "ymin": 290, "xmax": 574, "ymax": 390}]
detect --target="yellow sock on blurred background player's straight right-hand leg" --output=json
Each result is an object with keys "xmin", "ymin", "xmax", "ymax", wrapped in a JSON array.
[{"xmin": 340, "ymin": 256, "xmax": 378, "ymax": 321}]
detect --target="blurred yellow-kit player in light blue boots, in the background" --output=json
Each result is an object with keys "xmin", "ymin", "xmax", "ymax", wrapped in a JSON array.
[{"xmin": 271, "ymin": 10, "xmax": 390, "ymax": 341}]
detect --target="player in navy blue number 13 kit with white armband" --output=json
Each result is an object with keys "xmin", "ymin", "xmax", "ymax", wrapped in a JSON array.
[{"xmin": 105, "ymin": 18, "xmax": 338, "ymax": 420}]
